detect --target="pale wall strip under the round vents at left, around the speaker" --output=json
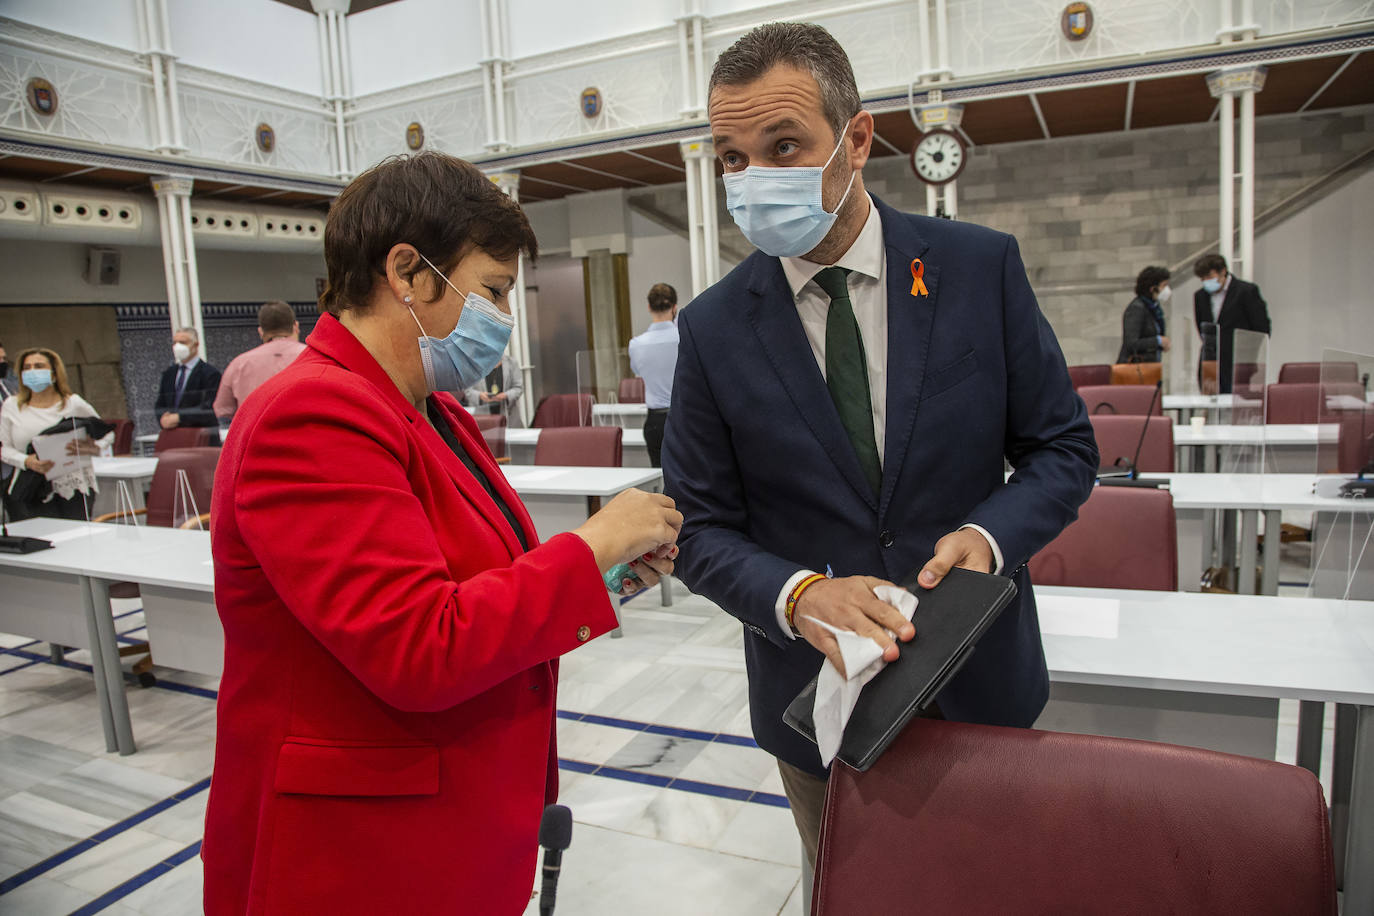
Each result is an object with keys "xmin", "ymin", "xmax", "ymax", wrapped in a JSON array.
[{"xmin": 0, "ymin": 240, "xmax": 324, "ymax": 305}]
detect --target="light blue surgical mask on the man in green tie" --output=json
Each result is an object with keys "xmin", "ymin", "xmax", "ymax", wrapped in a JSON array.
[{"xmin": 724, "ymin": 125, "xmax": 859, "ymax": 258}]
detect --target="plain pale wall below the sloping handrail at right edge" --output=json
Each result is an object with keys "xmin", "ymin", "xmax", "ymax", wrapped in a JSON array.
[{"xmin": 1258, "ymin": 169, "xmax": 1374, "ymax": 373}]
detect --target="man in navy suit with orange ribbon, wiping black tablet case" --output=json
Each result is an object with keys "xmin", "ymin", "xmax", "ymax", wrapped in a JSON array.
[{"xmin": 664, "ymin": 23, "xmax": 1098, "ymax": 865}]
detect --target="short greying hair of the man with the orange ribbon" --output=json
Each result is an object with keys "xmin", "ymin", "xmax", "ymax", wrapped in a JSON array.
[{"xmin": 706, "ymin": 22, "xmax": 863, "ymax": 139}]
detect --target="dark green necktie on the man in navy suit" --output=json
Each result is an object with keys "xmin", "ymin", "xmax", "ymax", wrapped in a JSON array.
[{"xmin": 815, "ymin": 268, "xmax": 882, "ymax": 496}]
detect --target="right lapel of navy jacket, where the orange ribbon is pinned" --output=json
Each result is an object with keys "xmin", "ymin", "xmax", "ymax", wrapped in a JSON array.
[{"xmin": 878, "ymin": 203, "xmax": 940, "ymax": 518}]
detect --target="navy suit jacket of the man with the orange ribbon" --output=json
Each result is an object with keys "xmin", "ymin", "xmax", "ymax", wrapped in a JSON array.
[{"xmin": 662, "ymin": 202, "xmax": 1098, "ymax": 776}]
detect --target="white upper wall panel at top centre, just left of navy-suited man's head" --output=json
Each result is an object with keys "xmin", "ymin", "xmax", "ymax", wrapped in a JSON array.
[{"xmin": 502, "ymin": 0, "xmax": 682, "ymax": 58}]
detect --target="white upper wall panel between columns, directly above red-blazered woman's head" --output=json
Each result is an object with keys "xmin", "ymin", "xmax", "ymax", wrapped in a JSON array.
[{"xmin": 348, "ymin": 0, "xmax": 483, "ymax": 95}]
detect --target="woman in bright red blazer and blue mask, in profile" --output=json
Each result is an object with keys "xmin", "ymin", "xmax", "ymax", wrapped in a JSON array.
[{"xmin": 201, "ymin": 154, "xmax": 682, "ymax": 916}]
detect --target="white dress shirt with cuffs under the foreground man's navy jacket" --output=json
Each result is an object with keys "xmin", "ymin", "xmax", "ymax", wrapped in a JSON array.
[{"xmin": 775, "ymin": 196, "xmax": 1002, "ymax": 637}]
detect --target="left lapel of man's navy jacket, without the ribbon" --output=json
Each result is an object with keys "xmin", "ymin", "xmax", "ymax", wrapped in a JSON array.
[{"xmin": 745, "ymin": 254, "xmax": 878, "ymax": 511}]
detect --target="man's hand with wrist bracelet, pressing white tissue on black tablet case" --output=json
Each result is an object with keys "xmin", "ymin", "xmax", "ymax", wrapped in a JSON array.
[{"xmin": 793, "ymin": 576, "xmax": 912, "ymax": 676}]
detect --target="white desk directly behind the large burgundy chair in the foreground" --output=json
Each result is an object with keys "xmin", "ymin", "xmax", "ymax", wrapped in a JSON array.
[{"xmin": 1035, "ymin": 586, "xmax": 1374, "ymax": 913}]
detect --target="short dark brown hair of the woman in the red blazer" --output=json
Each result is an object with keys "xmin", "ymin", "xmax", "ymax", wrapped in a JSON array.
[{"xmin": 320, "ymin": 151, "xmax": 539, "ymax": 316}]
